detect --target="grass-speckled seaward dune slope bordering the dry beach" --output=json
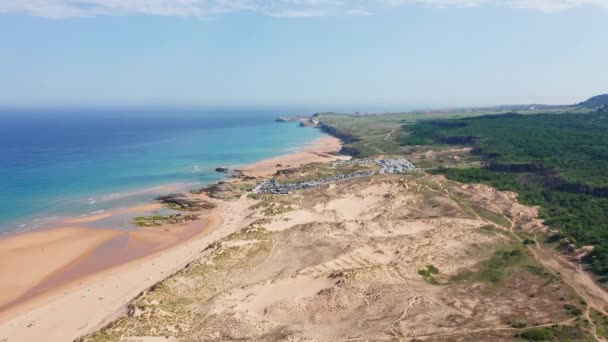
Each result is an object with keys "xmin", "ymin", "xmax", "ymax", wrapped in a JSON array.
[{"xmin": 79, "ymin": 228, "xmax": 272, "ymax": 342}]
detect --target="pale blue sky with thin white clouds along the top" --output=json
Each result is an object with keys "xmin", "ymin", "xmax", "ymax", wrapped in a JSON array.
[{"xmin": 0, "ymin": 0, "xmax": 608, "ymax": 111}]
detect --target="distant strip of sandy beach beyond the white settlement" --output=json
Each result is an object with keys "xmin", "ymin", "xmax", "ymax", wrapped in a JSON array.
[{"xmin": 242, "ymin": 136, "xmax": 350, "ymax": 177}]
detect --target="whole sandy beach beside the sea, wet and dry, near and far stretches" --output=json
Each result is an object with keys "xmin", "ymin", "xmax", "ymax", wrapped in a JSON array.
[{"xmin": 0, "ymin": 136, "xmax": 347, "ymax": 341}]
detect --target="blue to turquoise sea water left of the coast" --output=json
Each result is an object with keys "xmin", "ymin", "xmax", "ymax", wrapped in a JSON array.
[{"xmin": 0, "ymin": 111, "xmax": 323, "ymax": 232}]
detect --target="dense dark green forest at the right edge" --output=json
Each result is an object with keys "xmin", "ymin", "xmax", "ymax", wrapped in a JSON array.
[{"xmin": 399, "ymin": 110, "xmax": 608, "ymax": 280}]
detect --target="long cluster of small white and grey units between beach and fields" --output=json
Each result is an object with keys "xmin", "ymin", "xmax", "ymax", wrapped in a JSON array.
[{"xmin": 251, "ymin": 158, "xmax": 416, "ymax": 194}]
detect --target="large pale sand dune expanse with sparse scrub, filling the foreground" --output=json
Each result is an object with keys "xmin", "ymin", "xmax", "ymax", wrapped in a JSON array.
[{"xmin": 81, "ymin": 176, "xmax": 570, "ymax": 341}]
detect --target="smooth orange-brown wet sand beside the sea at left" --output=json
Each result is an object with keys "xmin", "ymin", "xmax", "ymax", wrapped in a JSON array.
[{"xmin": 0, "ymin": 213, "xmax": 213, "ymax": 320}]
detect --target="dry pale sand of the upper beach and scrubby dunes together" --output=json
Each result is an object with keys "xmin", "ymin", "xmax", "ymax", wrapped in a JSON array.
[{"xmin": 30, "ymin": 175, "xmax": 600, "ymax": 342}]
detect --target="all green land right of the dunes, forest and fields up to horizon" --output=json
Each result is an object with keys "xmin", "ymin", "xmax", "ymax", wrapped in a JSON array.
[{"xmin": 320, "ymin": 105, "xmax": 608, "ymax": 278}]
